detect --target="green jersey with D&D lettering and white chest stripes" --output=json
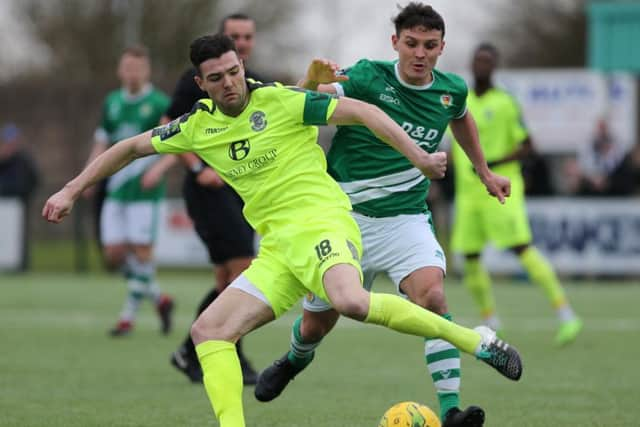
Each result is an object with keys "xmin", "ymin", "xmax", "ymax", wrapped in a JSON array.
[{"xmin": 327, "ymin": 59, "xmax": 467, "ymax": 217}]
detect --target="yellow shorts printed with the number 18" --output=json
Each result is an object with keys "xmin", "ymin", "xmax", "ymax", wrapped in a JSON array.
[{"xmin": 243, "ymin": 217, "xmax": 362, "ymax": 317}]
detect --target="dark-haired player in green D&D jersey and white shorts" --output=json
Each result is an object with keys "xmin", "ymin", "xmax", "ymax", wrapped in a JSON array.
[{"xmin": 255, "ymin": 3, "xmax": 509, "ymax": 427}]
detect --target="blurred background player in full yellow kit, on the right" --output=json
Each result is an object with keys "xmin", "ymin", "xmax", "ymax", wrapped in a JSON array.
[{"xmin": 451, "ymin": 43, "xmax": 582, "ymax": 345}]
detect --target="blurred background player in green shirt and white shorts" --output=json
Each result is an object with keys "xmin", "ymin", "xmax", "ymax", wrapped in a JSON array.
[{"xmin": 86, "ymin": 46, "xmax": 173, "ymax": 336}]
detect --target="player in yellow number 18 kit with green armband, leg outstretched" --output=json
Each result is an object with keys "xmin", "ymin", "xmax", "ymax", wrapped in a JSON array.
[{"xmin": 42, "ymin": 35, "xmax": 522, "ymax": 427}]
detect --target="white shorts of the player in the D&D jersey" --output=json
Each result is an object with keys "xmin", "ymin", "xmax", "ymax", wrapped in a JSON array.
[{"xmin": 302, "ymin": 212, "xmax": 447, "ymax": 311}]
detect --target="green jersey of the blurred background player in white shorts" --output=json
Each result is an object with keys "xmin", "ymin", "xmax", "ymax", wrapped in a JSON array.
[{"xmin": 95, "ymin": 85, "xmax": 170, "ymax": 201}]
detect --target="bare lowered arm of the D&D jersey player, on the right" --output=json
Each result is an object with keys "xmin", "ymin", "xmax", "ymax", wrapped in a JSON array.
[{"xmin": 449, "ymin": 111, "xmax": 511, "ymax": 203}]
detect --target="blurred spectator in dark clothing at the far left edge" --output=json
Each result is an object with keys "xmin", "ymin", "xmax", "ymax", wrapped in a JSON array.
[{"xmin": 0, "ymin": 123, "xmax": 38, "ymax": 271}]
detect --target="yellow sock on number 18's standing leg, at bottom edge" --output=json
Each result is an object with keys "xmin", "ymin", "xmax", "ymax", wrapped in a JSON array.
[{"xmin": 196, "ymin": 341, "xmax": 245, "ymax": 427}]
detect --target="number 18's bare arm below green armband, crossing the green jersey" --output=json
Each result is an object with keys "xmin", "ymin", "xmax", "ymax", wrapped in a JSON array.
[{"xmin": 329, "ymin": 97, "xmax": 447, "ymax": 179}]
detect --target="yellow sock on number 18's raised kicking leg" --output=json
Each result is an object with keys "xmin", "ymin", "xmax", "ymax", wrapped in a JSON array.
[{"xmin": 364, "ymin": 292, "xmax": 480, "ymax": 354}]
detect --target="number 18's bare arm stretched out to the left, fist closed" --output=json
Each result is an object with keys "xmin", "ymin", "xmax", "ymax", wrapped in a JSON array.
[{"xmin": 42, "ymin": 131, "xmax": 156, "ymax": 223}]
